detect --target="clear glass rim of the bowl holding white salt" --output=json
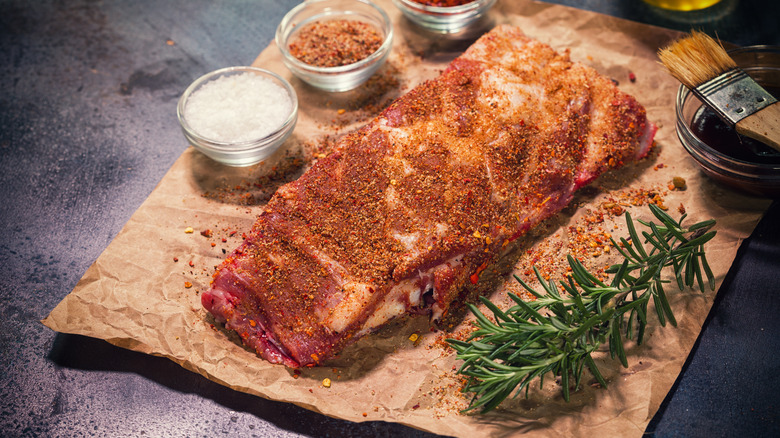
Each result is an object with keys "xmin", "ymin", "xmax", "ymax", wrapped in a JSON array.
[{"xmin": 176, "ymin": 66, "xmax": 298, "ymax": 154}]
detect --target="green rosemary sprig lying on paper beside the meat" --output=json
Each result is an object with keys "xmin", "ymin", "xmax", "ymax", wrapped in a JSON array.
[{"xmin": 447, "ymin": 204, "xmax": 716, "ymax": 412}]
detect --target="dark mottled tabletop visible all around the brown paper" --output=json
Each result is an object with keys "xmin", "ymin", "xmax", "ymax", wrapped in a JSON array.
[{"xmin": 0, "ymin": 0, "xmax": 780, "ymax": 437}]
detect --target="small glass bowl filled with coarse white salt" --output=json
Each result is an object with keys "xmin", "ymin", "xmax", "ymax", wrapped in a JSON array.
[{"xmin": 176, "ymin": 67, "xmax": 298, "ymax": 167}]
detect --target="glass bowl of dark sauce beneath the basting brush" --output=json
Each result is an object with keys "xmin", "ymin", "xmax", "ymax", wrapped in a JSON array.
[{"xmin": 675, "ymin": 46, "xmax": 780, "ymax": 198}]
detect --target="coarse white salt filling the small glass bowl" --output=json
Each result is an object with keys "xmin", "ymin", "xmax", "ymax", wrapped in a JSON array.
[{"xmin": 184, "ymin": 73, "xmax": 293, "ymax": 143}]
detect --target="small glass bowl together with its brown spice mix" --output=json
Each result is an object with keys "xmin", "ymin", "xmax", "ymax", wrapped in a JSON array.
[{"xmin": 276, "ymin": 0, "xmax": 393, "ymax": 91}]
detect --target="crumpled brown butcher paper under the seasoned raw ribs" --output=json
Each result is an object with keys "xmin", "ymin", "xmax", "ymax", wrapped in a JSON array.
[{"xmin": 43, "ymin": 0, "xmax": 769, "ymax": 437}]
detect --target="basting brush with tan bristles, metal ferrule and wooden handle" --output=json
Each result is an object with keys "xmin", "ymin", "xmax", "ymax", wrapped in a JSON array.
[{"xmin": 658, "ymin": 31, "xmax": 780, "ymax": 151}]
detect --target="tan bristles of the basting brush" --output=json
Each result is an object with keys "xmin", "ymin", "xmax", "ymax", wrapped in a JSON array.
[{"xmin": 658, "ymin": 31, "xmax": 737, "ymax": 88}]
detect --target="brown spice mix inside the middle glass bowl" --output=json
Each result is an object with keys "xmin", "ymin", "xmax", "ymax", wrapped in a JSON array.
[{"xmin": 289, "ymin": 20, "xmax": 383, "ymax": 67}]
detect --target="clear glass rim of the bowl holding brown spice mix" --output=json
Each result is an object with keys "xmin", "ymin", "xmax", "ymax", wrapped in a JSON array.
[{"xmin": 274, "ymin": 0, "xmax": 394, "ymax": 75}]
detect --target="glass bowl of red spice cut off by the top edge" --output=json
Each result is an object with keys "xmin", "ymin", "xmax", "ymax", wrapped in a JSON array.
[{"xmin": 393, "ymin": 0, "xmax": 496, "ymax": 33}]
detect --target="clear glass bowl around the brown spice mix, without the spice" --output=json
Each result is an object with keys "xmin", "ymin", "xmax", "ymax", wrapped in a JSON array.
[{"xmin": 276, "ymin": 0, "xmax": 393, "ymax": 92}]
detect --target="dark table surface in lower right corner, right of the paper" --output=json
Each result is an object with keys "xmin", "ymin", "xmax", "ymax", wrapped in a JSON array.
[{"xmin": 647, "ymin": 201, "xmax": 780, "ymax": 437}]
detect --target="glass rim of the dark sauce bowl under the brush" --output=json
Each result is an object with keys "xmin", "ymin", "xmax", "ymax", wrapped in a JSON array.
[{"xmin": 675, "ymin": 45, "xmax": 780, "ymax": 172}]
